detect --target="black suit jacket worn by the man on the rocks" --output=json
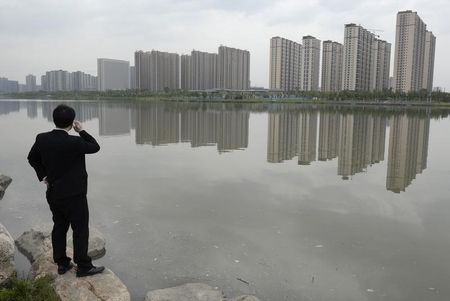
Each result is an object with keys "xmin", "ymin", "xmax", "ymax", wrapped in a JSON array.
[{"xmin": 28, "ymin": 130, "xmax": 100, "ymax": 199}]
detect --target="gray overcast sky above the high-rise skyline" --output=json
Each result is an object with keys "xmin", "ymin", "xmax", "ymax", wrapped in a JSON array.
[{"xmin": 0, "ymin": 0, "xmax": 450, "ymax": 91}]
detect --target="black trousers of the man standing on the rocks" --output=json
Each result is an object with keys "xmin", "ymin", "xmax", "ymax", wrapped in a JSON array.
[{"xmin": 47, "ymin": 189, "xmax": 93, "ymax": 270}]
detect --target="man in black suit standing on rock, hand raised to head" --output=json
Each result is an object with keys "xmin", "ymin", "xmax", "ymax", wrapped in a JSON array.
[{"xmin": 28, "ymin": 105, "xmax": 104, "ymax": 277}]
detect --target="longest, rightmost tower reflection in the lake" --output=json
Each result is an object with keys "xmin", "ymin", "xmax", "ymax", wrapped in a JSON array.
[{"xmin": 386, "ymin": 115, "xmax": 430, "ymax": 193}]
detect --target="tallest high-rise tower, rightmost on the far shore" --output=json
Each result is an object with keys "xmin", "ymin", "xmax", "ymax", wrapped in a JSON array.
[{"xmin": 394, "ymin": 10, "xmax": 436, "ymax": 92}]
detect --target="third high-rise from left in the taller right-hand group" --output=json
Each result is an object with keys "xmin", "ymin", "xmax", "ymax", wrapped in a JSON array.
[{"xmin": 321, "ymin": 41, "xmax": 344, "ymax": 92}]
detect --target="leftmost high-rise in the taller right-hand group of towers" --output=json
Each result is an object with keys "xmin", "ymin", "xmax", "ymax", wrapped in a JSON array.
[{"xmin": 269, "ymin": 37, "xmax": 302, "ymax": 91}]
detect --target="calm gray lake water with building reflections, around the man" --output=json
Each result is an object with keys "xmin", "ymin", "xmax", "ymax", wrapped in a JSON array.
[{"xmin": 0, "ymin": 100, "xmax": 450, "ymax": 301}]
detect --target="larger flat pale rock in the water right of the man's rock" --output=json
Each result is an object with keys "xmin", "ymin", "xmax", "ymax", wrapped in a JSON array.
[{"xmin": 145, "ymin": 283, "xmax": 224, "ymax": 301}]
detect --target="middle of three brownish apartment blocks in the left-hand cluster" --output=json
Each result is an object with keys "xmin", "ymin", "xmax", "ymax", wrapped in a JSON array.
[{"xmin": 181, "ymin": 50, "xmax": 217, "ymax": 90}]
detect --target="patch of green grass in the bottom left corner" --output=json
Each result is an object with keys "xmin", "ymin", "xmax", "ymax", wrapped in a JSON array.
[{"xmin": 0, "ymin": 277, "xmax": 60, "ymax": 301}]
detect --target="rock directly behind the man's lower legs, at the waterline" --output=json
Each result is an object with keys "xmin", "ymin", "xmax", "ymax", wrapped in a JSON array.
[{"xmin": 16, "ymin": 224, "xmax": 106, "ymax": 262}]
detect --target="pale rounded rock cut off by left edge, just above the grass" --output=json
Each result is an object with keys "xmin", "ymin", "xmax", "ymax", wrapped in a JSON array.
[{"xmin": 0, "ymin": 224, "xmax": 15, "ymax": 287}]
